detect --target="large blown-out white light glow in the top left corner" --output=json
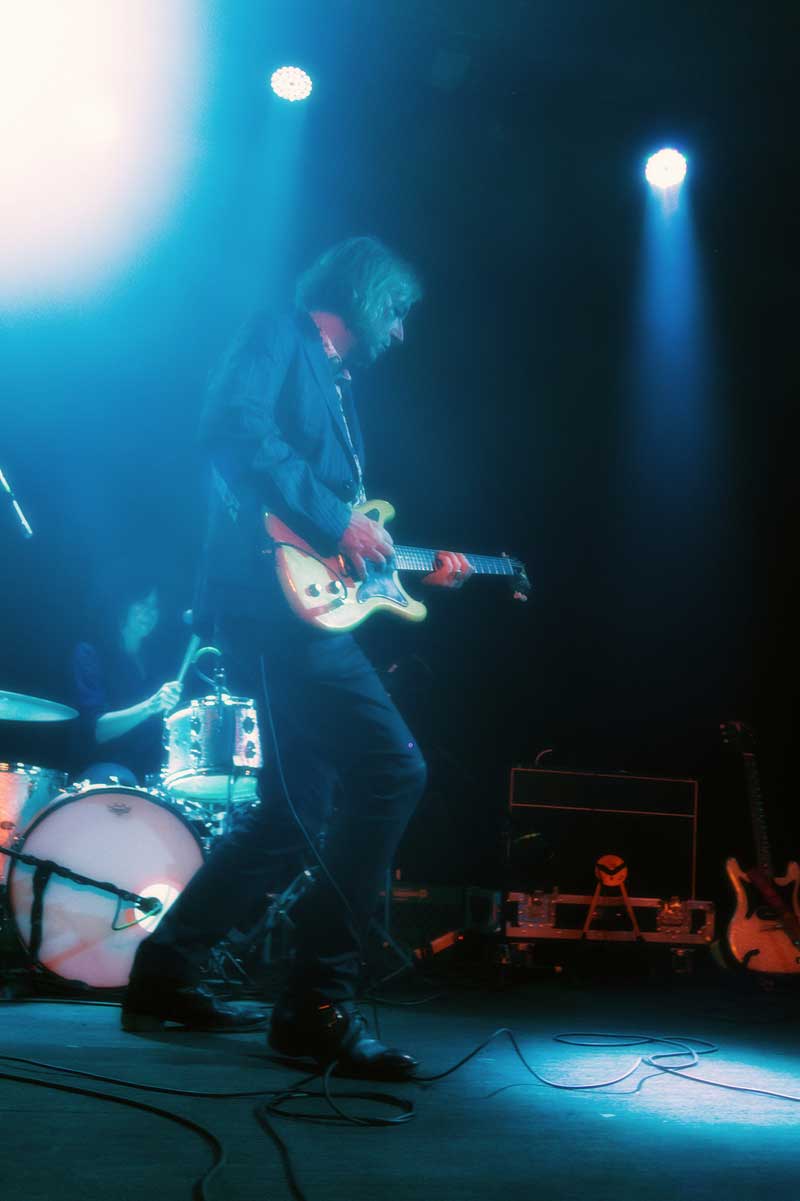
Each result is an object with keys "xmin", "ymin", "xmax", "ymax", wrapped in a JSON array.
[{"xmin": 0, "ymin": 0, "xmax": 205, "ymax": 310}]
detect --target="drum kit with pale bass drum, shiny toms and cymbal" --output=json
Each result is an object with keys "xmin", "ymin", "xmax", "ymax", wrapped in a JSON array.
[{"xmin": 0, "ymin": 689, "xmax": 263, "ymax": 988}]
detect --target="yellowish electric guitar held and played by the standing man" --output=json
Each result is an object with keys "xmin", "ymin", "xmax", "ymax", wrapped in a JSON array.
[{"xmin": 264, "ymin": 501, "xmax": 531, "ymax": 632}]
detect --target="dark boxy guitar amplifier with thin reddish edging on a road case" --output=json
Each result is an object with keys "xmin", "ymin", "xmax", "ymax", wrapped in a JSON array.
[{"xmin": 507, "ymin": 767, "xmax": 698, "ymax": 900}]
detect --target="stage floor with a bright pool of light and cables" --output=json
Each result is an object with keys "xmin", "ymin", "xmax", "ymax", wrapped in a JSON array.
[{"xmin": 0, "ymin": 978, "xmax": 800, "ymax": 1201}]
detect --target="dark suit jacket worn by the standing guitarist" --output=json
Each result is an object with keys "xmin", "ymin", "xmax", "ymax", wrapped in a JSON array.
[{"xmin": 195, "ymin": 311, "xmax": 364, "ymax": 628}]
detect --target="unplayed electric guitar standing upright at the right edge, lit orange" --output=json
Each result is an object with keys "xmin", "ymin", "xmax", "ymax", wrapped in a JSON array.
[{"xmin": 720, "ymin": 722, "xmax": 800, "ymax": 975}]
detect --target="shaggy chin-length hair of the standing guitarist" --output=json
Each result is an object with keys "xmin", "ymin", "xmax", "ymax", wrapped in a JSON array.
[{"xmin": 295, "ymin": 237, "xmax": 423, "ymax": 337}]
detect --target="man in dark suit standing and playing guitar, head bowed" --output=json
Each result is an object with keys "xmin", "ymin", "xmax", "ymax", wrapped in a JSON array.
[{"xmin": 123, "ymin": 238, "xmax": 472, "ymax": 1078}]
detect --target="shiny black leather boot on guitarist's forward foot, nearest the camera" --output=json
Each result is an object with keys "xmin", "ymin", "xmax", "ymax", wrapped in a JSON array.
[{"xmin": 268, "ymin": 997, "xmax": 418, "ymax": 1080}]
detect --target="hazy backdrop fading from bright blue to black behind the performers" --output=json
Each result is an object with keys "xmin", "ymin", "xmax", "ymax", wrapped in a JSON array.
[{"xmin": 0, "ymin": 0, "xmax": 800, "ymax": 896}]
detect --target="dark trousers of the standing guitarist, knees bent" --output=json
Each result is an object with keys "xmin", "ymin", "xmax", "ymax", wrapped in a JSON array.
[{"xmin": 133, "ymin": 619, "xmax": 425, "ymax": 999}]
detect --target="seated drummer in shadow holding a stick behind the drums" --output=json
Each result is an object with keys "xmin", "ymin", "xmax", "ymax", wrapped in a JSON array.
[{"xmin": 72, "ymin": 575, "xmax": 183, "ymax": 787}]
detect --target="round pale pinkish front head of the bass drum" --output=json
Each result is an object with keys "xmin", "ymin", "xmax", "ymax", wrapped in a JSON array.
[{"xmin": 8, "ymin": 784, "xmax": 203, "ymax": 988}]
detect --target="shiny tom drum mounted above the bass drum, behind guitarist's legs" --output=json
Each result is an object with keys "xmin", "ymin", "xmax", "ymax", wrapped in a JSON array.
[{"xmin": 161, "ymin": 694, "xmax": 263, "ymax": 806}]
